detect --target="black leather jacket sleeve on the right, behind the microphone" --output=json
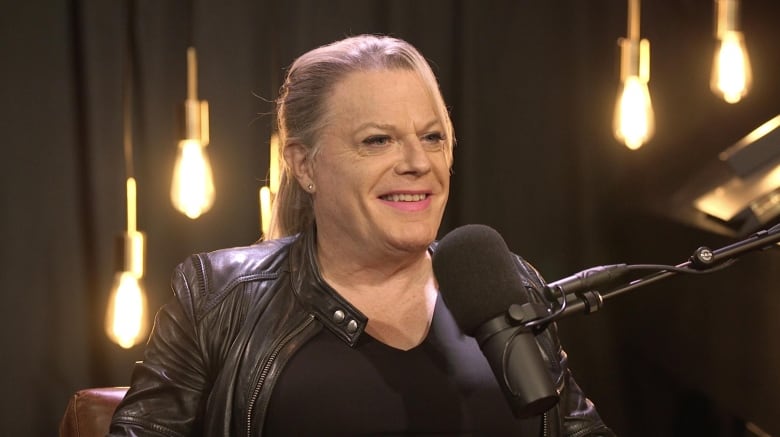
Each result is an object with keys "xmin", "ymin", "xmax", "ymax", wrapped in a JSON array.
[{"xmin": 517, "ymin": 257, "xmax": 615, "ymax": 437}]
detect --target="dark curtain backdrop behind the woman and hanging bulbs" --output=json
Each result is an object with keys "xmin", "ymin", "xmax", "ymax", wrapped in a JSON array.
[{"xmin": 0, "ymin": 0, "xmax": 780, "ymax": 436}]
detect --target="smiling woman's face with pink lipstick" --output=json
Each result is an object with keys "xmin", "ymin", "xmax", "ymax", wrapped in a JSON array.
[{"xmin": 302, "ymin": 70, "xmax": 450, "ymax": 256}]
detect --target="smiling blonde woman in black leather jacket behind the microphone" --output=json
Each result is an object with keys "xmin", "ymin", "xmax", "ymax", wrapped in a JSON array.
[{"xmin": 111, "ymin": 35, "xmax": 611, "ymax": 436}]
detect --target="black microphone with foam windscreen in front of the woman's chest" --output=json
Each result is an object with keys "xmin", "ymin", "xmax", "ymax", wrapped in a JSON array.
[{"xmin": 433, "ymin": 225, "xmax": 558, "ymax": 418}]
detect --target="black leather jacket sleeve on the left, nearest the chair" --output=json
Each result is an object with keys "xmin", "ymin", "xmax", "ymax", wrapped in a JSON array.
[{"xmin": 108, "ymin": 263, "xmax": 207, "ymax": 437}]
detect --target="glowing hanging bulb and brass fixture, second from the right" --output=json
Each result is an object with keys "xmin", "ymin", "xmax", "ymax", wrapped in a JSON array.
[{"xmin": 613, "ymin": 0, "xmax": 655, "ymax": 150}]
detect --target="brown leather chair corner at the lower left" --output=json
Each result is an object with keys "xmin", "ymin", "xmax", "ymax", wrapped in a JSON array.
[{"xmin": 60, "ymin": 387, "xmax": 127, "ymax": 437}]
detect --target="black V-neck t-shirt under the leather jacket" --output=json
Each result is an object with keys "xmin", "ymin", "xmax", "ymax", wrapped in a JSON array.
[{"xmin": 264, "ymin": 297, "xmax": 541, "ymax": 436}]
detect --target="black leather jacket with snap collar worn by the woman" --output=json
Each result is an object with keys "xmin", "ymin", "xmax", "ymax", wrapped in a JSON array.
[{"xmin": 109, "ymin": 233, "xmax": 612, "ymax": 437}]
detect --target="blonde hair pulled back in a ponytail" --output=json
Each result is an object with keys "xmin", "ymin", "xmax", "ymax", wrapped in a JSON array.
[{"xmin": 265, "ymin": 35, "xmax": 454, "ymax": 239}]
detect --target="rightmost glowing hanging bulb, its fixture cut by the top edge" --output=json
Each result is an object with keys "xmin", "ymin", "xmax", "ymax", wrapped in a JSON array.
[{"xmin": 710, "ymin": 0, "xmax": 753, "ymax": 103}]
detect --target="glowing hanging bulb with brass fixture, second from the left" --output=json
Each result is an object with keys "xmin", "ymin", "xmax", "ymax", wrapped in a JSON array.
[{"xmin": 171, "ymin": 47, "xmax": 215, "ymax": 219}]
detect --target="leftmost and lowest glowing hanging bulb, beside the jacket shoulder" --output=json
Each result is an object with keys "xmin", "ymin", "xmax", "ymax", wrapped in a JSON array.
[{"xmin": 105, "ymin": 177, "xmax": 148, "ymax": 349}]
